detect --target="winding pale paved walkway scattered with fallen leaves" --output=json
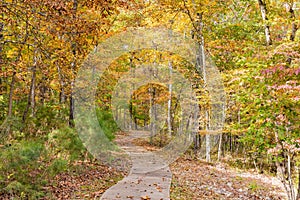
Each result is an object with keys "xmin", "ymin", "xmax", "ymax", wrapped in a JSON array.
[{"xmin": 101, "ymin": 131, "xmax": 172, "ymax": 200}]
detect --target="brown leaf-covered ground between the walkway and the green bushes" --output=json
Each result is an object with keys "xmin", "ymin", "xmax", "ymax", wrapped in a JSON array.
[{"xmin": 44, "ymin": 162, "xmax": 125, "ymax": 200}]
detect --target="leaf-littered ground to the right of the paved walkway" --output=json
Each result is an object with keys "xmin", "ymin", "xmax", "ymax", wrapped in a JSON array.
[{"xmin": 170, "ymin": 158, "xmax": 286, "ymax": 200}]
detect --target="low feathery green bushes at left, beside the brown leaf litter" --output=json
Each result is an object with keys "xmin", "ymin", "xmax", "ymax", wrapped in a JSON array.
[{"xmin": 0, "ymin": 127, "xmax": 86, "ymax": 199}]
